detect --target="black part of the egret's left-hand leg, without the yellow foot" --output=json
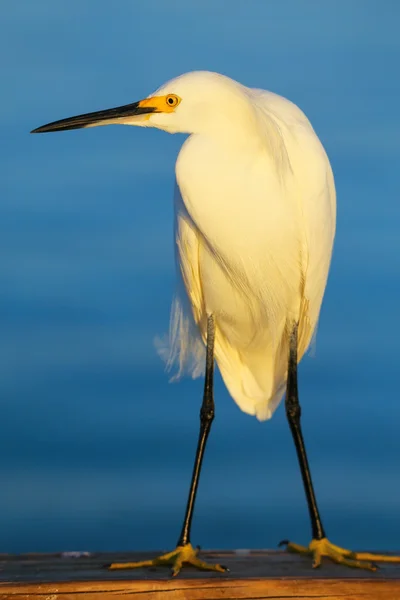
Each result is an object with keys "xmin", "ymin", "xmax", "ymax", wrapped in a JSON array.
[{"xmin": 178, "ymin": 315, "xmax": 215, "ymax": 546}]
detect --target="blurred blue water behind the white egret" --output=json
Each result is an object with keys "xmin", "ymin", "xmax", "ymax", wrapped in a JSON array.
[{"xmin": 0, "ymin": 0, "xmax": 400, "ymax": 552}]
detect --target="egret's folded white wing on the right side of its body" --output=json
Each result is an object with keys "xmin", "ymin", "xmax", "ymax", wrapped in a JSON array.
[{"xmin": 249, "ymin": 90, "xmax": 336, "ymax": 358}]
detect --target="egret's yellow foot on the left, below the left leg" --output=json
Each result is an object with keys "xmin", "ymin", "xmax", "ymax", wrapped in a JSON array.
[{"xmin": 108, "ymin": 544, "xmax": 228, "ymax": 577}]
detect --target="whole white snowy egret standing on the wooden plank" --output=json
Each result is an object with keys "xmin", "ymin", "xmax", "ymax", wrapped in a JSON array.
[{"xmin": 29, "ymin": 72, "xmax": 398, "ymax": 575}]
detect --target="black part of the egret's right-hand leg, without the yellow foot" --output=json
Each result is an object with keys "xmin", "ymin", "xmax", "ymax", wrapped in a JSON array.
[{"xmin": 286, "ymin": 324, "xmax": 325, "ymax": 540}]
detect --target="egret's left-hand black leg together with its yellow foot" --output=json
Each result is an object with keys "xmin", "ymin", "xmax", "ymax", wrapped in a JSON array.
[{"xmin": 109, "ymin": 315, "xmax": 227, "ymax": 576}]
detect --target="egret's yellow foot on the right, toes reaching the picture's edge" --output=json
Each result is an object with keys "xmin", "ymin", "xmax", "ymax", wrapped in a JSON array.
[{"xmin": 279, "ymin": 538, "xmax": 400, "ymax": 571}]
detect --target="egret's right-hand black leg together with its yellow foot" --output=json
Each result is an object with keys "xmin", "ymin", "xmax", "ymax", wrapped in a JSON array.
[{"xmin": 280, "ymin": 324, "xmax": 400, "ymax": 571}]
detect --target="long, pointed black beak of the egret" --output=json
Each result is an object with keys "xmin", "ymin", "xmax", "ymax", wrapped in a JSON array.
[{"xmin": 31, "ymin": 101, "xmax": 157, "ymax": 133}]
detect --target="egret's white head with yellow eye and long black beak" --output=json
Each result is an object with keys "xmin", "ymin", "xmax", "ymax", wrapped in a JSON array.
[{"xmin": 32, "ymin": 71, "xmax": 252, "ymax": 133}]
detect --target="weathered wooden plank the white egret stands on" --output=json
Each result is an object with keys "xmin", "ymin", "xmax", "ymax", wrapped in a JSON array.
[{"xmin": 0, "ymin": 550, "xmax": 400, "ymax": 600}]
